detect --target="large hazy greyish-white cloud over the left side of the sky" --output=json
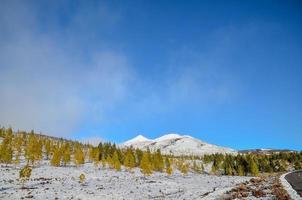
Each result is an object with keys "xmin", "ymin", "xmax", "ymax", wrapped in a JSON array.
[{"xmin": 0, "ymin": 0, "xmax": 132, "ymax": 135}]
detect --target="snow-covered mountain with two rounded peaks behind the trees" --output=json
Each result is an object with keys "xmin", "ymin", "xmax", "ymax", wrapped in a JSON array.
[{"xmin": 122, "ymin": 133, "xmax": 237, "ymax": 156}]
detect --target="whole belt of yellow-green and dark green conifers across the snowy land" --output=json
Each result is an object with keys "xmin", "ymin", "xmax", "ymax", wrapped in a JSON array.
[{"xmin": 0, "ymin": 128, "xmax": 302, "ymax": 176}]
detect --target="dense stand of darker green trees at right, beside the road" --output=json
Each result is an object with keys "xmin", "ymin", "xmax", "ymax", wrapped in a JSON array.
[{"xmin": 202, "ymin": 152, "xmax": 302, "ymax": 176}]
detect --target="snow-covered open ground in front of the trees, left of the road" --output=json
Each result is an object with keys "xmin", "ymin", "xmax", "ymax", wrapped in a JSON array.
[{"xmin": 0, "ymin": 163, "xmax": 250, "ymax": 199}]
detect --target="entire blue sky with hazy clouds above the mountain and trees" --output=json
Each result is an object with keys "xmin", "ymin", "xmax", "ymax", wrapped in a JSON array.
[{"xmin": 0, "ymin": 0, "xmax": 302, "ymax": 150}]
